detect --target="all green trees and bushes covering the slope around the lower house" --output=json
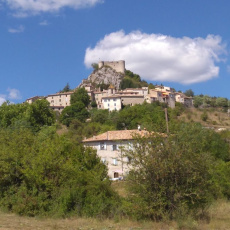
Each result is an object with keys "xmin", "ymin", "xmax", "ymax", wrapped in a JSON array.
[{"xmin": 0, "ymin": 83, "xmax": 230, "ymax": 226}]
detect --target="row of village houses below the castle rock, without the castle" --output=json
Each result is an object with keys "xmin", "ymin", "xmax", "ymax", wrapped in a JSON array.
[{"xmin": 26, "ymin": 84, "xmax": 193, "ymax": 112}]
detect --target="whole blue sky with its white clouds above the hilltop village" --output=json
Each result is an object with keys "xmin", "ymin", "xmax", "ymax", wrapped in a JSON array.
[{"xmin": 0, "ymin": 0, "xmax": 230, "ymax": 104}]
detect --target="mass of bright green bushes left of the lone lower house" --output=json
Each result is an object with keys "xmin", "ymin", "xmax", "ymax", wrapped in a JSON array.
[{"xmin": 0, "ymin": 129, "xmax": 118, "ymax": 217}]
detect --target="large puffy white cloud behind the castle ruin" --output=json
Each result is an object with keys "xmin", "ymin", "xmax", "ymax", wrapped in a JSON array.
[{"xmin": 85, "ymin": 31, "xmax": 226, "ymax": 84}]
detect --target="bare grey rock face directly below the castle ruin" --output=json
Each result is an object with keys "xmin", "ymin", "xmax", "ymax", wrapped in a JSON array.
[{"xmin": 78, "ymin": 66, "xmax": 124, "ymax": 89}]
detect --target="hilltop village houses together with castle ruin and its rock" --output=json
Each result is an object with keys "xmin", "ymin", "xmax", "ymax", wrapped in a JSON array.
[{"xmin": 26, "ymin": 61, "xmax": 193, "ymax": 112}]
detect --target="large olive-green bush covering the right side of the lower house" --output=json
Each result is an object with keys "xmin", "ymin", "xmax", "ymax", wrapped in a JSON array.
[{"xmin": 126, "ymin": 125, "xmax": 226, "ymax": 220}]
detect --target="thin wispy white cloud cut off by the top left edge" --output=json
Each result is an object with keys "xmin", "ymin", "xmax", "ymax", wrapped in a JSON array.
[{"xmin": 0, "ymin": 0, "xmax": 103, "ymax": 16}]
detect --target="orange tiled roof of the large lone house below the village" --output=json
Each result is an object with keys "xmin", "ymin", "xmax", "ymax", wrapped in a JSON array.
[{"xmin": 83, "ymin": 129, "xmax": 149, "ymax": 142}]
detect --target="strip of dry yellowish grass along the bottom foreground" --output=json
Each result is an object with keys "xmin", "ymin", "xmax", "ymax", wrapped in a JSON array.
[{"xmin": 0, "ymin": 200, "xmax": 230, "ymax": 230}]
